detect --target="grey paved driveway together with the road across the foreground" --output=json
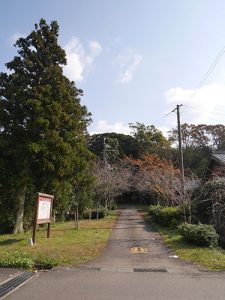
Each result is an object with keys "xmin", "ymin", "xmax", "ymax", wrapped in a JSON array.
[{"xmin": 5, "ymin": 208, "xmax": 225, "ymax": 300}]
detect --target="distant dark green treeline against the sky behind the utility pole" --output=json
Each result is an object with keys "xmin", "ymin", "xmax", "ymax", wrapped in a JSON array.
[{"xmin": 90, "ymin": 122, "xmax": 225, "ymax": 177}]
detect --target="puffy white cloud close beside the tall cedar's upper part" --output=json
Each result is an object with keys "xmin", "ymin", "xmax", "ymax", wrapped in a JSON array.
[{"xmin": 64, "ymin": 37, "xmax": 102, "ymax": 81}]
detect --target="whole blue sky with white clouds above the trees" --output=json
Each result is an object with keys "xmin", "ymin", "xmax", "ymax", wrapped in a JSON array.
[{"xmin": 0, "ymin": 0, "xmax": 225, "ymax": 133}]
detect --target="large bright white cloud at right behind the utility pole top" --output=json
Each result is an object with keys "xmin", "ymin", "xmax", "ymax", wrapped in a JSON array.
[{"xmin": 165, "ymin": 82, "xmax": 225, "ymax": 124}]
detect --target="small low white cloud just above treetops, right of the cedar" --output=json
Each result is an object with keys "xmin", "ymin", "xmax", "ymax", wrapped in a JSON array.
[{"xmin": 91, "ymin": 120, "xmax": 131, "ymax": 134}]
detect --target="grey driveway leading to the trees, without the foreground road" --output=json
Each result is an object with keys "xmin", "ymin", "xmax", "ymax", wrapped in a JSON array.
[{"xmin": 87, "ymin": 208, "xmax": 199, "ymax": 273}]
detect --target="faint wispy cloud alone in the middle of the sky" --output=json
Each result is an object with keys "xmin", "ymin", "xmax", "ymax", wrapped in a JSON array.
[{"xmin": 117, "ymin": 48, "xmax": 142, "ymax": 83}]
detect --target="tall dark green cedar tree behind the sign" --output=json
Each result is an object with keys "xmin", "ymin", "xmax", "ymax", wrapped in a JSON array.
[{"xmin": 0, "ymin": 19, "xmax": 92, "ymax": 232}]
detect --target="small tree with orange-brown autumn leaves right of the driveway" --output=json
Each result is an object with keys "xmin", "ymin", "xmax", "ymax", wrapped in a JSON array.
[{"xmin": 128, "ymin": 154, "xmax": 199, "ymax": 222}]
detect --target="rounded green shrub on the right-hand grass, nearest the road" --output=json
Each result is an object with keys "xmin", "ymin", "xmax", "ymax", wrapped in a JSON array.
[{"xmin": 178, "ymin": 223, "xmax": 219, "ymax": 247}]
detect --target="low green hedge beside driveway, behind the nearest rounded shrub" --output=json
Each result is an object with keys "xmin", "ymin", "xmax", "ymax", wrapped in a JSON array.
[{"xmin": 149, "ymin": 205, "xmax": 183, "ymax": 227}]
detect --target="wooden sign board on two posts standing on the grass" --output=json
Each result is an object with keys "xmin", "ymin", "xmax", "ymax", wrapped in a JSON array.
[{"xmin": 32, "ymin": 193, "xmax": 54, "ymax": 244}]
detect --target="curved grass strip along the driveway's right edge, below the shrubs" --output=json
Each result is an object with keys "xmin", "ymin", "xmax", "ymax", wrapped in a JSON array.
[{"xmin": 138, "ymin": 206, "xmax": 225, "ymax": 271}]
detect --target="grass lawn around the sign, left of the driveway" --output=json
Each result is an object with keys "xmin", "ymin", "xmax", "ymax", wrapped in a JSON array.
[{"xmin": 0, "ymin": 217, "xmax": 116, "ymax": 268}]
